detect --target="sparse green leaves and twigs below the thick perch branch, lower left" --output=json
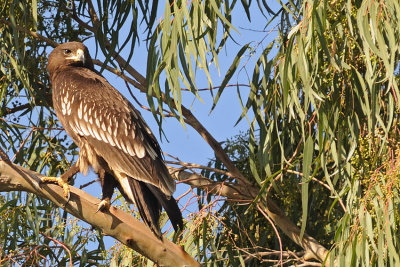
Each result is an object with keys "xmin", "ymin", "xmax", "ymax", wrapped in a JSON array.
[{"xmin": 0, "ymin": 192, "xmax": 104, "ymax": 266}]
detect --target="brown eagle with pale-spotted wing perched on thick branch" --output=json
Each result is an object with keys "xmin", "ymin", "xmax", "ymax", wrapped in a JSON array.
[{"xmin": 42, "ymin": 42, "xmax": 183, "ymax": 239}]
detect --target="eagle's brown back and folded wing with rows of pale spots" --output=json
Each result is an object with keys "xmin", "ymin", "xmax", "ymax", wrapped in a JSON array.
[{"xmin": 53, "ymin": 68, "xmax": 175, "ymax": 196}]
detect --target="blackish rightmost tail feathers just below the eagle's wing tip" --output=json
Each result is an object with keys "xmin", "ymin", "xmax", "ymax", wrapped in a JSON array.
[{"xmin": 147, "ymin": 184, "xmax": 183, "ymax": 231}]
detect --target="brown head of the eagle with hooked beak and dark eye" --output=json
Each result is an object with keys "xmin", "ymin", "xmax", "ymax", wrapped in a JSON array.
[{"xmin": 47, "ymin": 42, "xmax": 94, "ymax": 76}]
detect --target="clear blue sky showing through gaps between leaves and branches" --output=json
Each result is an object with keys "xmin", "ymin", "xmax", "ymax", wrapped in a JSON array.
[{"xmin": 61, "ymin": 3, "xmax": 282, "ymax": 253}]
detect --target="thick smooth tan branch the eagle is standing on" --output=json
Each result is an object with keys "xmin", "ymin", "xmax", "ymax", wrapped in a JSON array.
[{"xmin": 0, "ymin": 161, "xmax": 200, "ymax": 266}]
